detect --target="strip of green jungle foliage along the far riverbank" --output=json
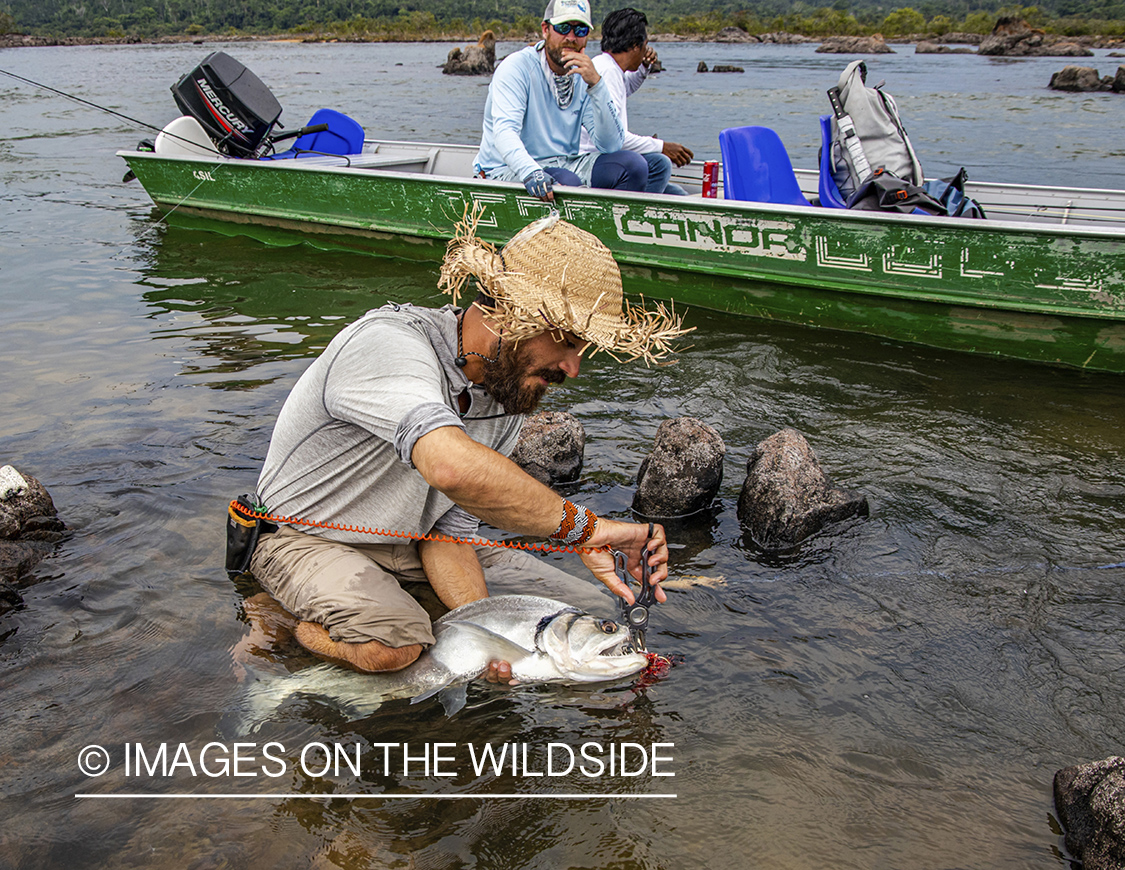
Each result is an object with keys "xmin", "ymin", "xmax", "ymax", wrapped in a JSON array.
[{"xmin": 0, "ymin": 0, "xmax": 1125, "ymax": 39}]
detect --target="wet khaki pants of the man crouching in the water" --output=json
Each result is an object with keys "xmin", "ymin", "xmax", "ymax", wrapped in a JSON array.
[{"xmin": 250, "ymin": 526, "xmax": 617, "ymax": 648}]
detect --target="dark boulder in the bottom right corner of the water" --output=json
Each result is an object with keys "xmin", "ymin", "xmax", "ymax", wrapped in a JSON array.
[{"xmin": 1054, "ymin": 755, "xmax": 1125, "ymax": 870}]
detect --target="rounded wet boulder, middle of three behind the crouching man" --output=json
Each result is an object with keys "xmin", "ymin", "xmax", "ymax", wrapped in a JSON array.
[{"xmin": 632, "ymin": 416, "xmax": 727, "ymax": 519}]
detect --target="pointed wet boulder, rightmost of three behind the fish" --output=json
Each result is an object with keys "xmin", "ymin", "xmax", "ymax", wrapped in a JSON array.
[{"xmin": 738, "ymin": 429, "xmax": 867, "ymax": 550}]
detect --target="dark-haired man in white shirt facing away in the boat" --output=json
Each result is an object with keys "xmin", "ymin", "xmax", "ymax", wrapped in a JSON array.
[{"xmin": 582, "ymin": 7, "xmax": 694, "ymax": 196}]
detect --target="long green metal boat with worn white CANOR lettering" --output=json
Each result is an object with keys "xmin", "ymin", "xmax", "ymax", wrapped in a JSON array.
[{"xmin": 118, "ymin": 133, "xmax": 1125, "ymax": 373}]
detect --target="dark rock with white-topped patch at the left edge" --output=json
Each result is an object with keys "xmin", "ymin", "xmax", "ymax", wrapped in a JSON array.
[{"xmin": 0, "ymin": 465, "xmax": 66, "ymax": 583}]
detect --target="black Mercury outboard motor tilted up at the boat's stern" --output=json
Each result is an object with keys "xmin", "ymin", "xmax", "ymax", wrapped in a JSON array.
[{"xmin": 172, "ymin": 52, "xmax": 281, "ymax": 158}]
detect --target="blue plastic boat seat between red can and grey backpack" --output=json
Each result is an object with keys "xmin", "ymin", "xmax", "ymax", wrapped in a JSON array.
[{"xmin": 719, "ymin": 127, "xmax": 809, "ymax": 206}]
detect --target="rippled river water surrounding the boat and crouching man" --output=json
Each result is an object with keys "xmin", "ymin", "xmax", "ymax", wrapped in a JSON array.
[{"xmin": 0, "ymin": 43, "xmax": 1125, "ymax": 870}]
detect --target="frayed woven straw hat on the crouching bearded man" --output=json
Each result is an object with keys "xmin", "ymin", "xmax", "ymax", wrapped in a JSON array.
[{"xmin": 438, "ymin": 208, "xmax": 694, "ymax": 365}]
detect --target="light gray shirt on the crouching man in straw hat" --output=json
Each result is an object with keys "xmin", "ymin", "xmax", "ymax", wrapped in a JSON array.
[{"xmin": 258, "ymin": 304, "xmax": 523, "ymax": 544}]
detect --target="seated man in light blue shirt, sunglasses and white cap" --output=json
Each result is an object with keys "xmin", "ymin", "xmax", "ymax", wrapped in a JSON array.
[{"xmin": 474, "ymin": 0, "xmax": 648, "ymax": 200}]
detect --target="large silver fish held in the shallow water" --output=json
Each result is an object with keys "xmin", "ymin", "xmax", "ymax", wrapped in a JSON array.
[{"xmin": 240, "ymin": 595, "xmax": 648, "ymax": 730}]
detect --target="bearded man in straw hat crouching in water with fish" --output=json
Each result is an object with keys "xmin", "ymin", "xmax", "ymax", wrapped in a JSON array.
[{"xmin": 250, "ymin": 214, "xmax": 686, "ymax": 681}]
